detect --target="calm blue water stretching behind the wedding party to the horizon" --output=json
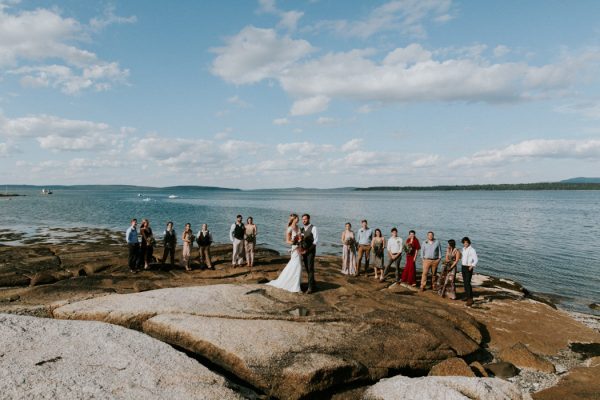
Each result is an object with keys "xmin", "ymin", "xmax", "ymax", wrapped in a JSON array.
[{"xmin": 0, "ymin": 187, "xmax": 600, "ymax": 314}]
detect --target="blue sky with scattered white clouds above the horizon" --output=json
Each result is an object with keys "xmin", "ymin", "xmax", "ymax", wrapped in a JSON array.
[{"xmin": 0, "ymin": 0, "xmax": 600, "ymax": 189}]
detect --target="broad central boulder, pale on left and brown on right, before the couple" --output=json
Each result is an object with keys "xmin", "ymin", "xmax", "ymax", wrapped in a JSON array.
[{"xmin": 53, "ymin": 285, "xmax": 481, "ymax": 398}]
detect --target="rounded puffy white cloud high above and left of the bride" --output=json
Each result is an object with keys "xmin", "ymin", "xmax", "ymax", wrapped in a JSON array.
[{"xmin": 212, "ymin": 26, "xmax": 313, "ymax": 84}]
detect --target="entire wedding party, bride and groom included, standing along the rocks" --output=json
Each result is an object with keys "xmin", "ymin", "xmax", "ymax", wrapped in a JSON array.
[{"xmin": 125, "ymin": 213, "xmax": 478, "ymax": 306}]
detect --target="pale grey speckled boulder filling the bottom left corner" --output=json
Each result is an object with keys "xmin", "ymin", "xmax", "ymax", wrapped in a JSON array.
[{"xmin": 0, "ymin": 314, "xmax": 241, "ymax": 399}]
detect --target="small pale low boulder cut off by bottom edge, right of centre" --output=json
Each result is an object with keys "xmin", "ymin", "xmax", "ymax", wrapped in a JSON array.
[{"xmin": 363, "ymin": 376, "xmax": 531, "ymax": 400}]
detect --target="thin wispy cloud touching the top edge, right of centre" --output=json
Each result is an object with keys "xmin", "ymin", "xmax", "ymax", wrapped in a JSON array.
[{"xmin": 310, "ymin": 0, "xmax": 452, "ymax": 39}]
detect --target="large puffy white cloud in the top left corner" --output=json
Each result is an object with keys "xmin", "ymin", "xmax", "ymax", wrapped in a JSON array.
[{"xmin": 0, "ymin": 7, "xmax": 129, "ymax": 94}]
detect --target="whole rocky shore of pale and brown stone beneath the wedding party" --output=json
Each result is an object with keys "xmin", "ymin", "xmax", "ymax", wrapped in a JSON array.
[{"xmin": 0, "ymin": 228, "xmax": 600, "ymax": 400}]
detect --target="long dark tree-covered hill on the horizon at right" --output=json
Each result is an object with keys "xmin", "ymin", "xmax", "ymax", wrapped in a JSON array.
[{"xmin": 355, "ymin": 182, "xmax": 600, "ymax": 191}]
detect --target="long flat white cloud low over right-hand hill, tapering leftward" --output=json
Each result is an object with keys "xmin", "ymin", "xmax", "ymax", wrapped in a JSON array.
[{"xmin": 449, "ymin": 139, "xmax": 600, "ymax": 167}]
